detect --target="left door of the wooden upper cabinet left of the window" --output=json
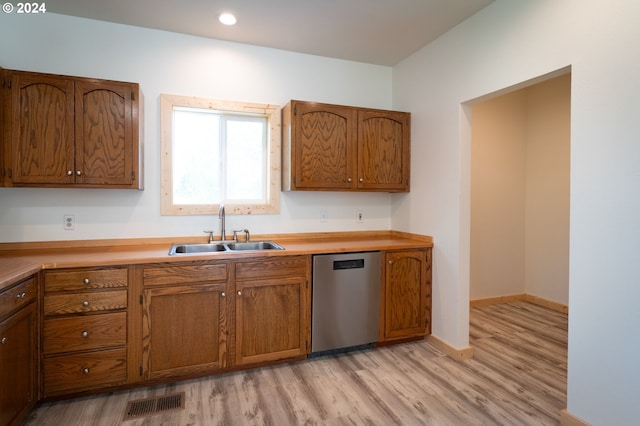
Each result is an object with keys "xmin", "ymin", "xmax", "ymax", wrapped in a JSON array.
[{"xmin": 8, "ymin": 72, "xmax": 75, "ymax": 184}]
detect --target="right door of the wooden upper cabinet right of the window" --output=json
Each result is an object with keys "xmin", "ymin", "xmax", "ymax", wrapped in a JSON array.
[{"xmin": 357, "ymin": 110, "xmax": 411, "ymax": 192}]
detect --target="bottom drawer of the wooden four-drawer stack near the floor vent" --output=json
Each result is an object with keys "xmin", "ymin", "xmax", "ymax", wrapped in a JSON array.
[{"xmin": 43, "ymin": 348, "xmax": 127, "ymax": 397}]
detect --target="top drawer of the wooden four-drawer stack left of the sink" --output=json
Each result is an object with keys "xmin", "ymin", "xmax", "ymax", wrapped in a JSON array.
[{"xmin": 44, "ymin": 268, "xmax": 129, "ymax": 292}]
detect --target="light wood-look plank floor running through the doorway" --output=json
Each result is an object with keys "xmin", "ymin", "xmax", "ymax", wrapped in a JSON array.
[{"xmin": 27, "ymin": 302, "xmax": 567, "ymax": 426}]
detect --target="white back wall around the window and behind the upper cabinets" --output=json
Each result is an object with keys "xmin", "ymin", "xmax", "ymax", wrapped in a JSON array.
[{"xmin": 0, "ymin": 13, "xmax": 392, "ymax": 242}]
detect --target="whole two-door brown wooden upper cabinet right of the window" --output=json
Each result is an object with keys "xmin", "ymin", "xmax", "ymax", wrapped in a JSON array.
[{"xmin": 282, "ymin": 100, "xmax": 411, "ymax": 192}]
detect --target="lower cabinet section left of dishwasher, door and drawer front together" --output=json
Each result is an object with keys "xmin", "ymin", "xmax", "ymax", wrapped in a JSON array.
[{"xmin": 235, "ymin": 256, "xmax": 311, "ymax": 365}]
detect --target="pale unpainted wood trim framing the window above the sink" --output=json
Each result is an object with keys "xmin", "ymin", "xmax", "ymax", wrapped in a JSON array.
[{"xmin": 160, "ymin": 94, "xmax": 282, "ymax": 216}]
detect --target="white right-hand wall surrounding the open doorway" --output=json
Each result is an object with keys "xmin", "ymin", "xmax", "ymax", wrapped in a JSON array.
[{"xmin": 392, "ymin": 0, "xmax": 640, "ymax": 425}]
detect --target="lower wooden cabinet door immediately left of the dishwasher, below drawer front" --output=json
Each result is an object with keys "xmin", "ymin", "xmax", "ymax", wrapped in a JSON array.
[{"xmin": 236, "ymin": 277, "xmax": 308, "ymax": 365}]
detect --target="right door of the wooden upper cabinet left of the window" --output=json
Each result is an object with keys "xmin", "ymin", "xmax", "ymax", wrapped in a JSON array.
[{"xmin": 75, "ymin": 80, "xmax": 138, "ymax": 186}]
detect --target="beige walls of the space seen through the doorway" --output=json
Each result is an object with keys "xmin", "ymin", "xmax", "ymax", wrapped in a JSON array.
[{"xmin": 469, "ymin": 74, "xmax": 571, "ymax": 305}]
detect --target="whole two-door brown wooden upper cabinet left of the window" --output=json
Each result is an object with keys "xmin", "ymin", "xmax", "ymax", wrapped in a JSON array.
[{"xmin": 2, "ymin": 70, "xmax": 142, "ymax": 189}]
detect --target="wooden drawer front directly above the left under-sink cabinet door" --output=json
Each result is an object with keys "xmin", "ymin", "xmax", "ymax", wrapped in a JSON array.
[{"xmin": 144, "ymin": 262, "xmax": 229, "ymax": 286}]
